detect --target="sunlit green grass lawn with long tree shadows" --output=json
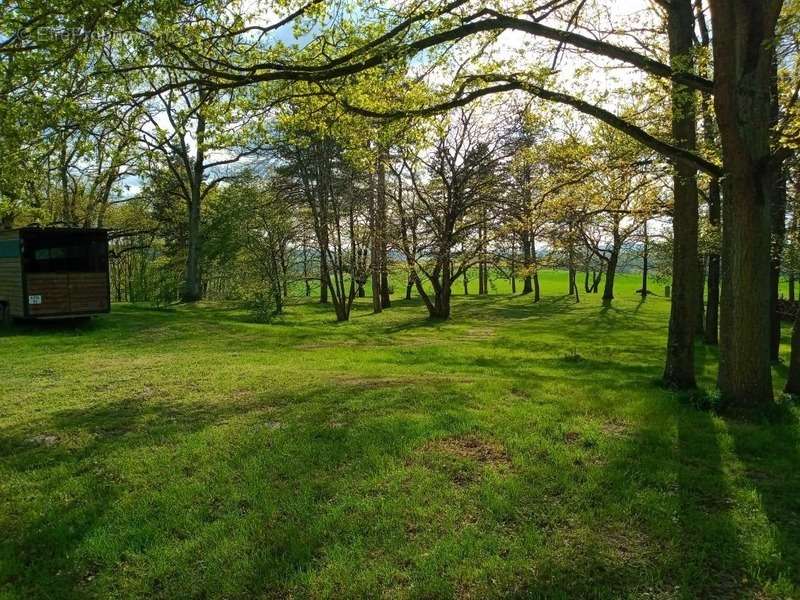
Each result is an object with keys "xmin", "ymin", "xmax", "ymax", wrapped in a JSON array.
[{"xmin": 0, "ymin": 273, "xmax": 800, "ymax": 599}]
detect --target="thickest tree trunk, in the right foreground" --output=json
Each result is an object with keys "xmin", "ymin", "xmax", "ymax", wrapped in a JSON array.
[{"xmin": 710, "ymin": 0, "xmax": 782, "ymax": 407}]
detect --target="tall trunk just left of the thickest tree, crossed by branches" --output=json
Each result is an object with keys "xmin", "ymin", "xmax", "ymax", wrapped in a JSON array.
[{"xmin": 664, "ymin": 0, "xmax": 698, "ymax": 389}]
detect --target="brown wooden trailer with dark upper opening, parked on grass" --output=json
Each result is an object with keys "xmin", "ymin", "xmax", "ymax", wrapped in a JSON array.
[{"xmin": 0, "ymin": 227, "xmax": 111, "ymax": 319}]
